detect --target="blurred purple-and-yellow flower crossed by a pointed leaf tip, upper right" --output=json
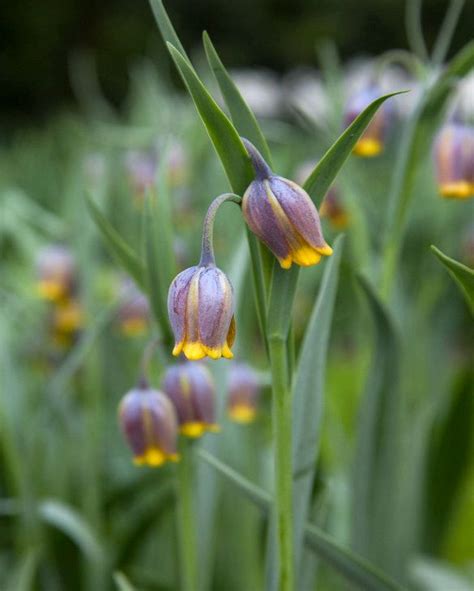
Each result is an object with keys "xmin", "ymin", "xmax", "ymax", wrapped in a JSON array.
[{"xmin": 344, "ymin": 85, "xmax": 393, "ymax": 158}]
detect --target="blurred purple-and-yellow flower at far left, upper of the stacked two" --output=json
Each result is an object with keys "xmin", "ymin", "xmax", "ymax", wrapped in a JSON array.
[{"xmin": 36, "ymin": 245, "xmax": 76, "ymax": 302}]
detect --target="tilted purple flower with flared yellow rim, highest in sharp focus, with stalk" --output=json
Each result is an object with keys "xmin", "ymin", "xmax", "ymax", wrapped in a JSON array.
[{"xmin": 242, "ymin": 138, "xmax": 332, "ymax": 269}]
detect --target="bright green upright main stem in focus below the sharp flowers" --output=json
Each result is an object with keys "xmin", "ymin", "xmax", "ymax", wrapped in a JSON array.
[{"xmin": 268, "ymin": 337, "xmax": 294, "ymax": 591}]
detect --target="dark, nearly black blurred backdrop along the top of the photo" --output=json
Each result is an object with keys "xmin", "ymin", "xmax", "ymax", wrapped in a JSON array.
[{"xmin": 0, "ymin": 0, "xmax": 474, "ymax": 127}]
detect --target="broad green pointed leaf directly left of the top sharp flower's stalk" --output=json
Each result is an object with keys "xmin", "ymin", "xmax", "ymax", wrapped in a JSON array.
[{"xmin": 168, "ymin": 43, "xmax": 253, "ymax": 195}]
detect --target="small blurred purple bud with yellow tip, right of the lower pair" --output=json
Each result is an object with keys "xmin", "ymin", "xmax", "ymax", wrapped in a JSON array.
[{"xmin": 227, "ymin": 363, "xmax": 260, "ymax": 423}]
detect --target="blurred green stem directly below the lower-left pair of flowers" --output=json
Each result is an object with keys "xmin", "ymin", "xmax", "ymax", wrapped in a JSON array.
[{"xmin": 177, "ymin": 438, "xmax": 198, "ymax": 591}]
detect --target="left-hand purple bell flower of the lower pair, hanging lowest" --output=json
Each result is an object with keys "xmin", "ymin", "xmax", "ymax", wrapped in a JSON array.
[{"xmin": 119, "ymin": 380, "xmax": 179, "ymax": 467}]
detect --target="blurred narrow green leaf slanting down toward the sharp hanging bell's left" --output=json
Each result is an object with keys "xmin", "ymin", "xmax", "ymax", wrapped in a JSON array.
[{"xmin": 86, "ymin": 197, "xmax": 145, "ymax": 288}]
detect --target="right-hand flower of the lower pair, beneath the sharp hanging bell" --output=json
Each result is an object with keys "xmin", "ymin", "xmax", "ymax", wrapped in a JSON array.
[{"xmin": 162, "ymin": 362, "xmax": 219, "ymax": 438}]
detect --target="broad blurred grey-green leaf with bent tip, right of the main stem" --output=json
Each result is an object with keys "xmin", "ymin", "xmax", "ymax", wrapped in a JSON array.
[{"xmin": 352, "ymin": 276, "xmax": 403, "ymax": 573}]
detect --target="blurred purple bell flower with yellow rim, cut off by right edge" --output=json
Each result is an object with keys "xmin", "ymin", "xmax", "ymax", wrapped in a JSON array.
[{"xmin": 434, "ymin": 121, "xmax": 474, "ymax": 199}]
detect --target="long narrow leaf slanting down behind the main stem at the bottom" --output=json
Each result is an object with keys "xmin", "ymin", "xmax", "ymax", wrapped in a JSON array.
[{"xmin": 199, "ymin": 450, "xmax": 401, "ymax": 591}]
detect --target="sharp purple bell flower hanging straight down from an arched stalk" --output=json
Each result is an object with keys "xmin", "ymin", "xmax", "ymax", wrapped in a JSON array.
[{"xmin": 168, "ymin": 264, "xmax": 235, "ymax": 360}]
